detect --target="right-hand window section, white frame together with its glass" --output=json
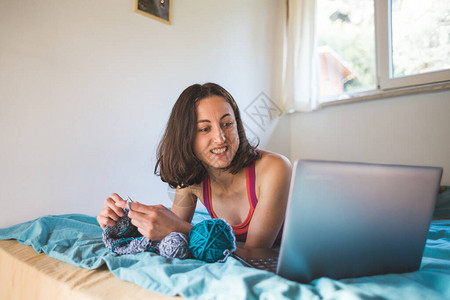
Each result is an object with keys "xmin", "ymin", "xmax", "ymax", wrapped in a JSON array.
[{"xmin": 377, "ymin": 0, "xmax": 450, "ymax": 89}]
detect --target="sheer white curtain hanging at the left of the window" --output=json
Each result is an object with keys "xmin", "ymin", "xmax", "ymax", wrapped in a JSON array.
[{"xmin": 283, "ymin": 0, "xmax": 319, "ymax": 112}]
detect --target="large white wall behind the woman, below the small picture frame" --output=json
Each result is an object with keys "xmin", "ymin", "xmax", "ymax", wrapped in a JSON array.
[{"xmin": 0, "ymin": 0, "xmax": 289, "ymax": 227}]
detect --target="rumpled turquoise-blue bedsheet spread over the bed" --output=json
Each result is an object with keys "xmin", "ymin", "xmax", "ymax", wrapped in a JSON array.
[{"xmin": 0, "ymin": 213, "xmax": 450, "ymax": 299}]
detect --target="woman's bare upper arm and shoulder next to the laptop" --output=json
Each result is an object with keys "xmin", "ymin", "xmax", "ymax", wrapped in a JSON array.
[{"xmin": 244, "ymin": 151, "xmax": 292, "ymax": 248}]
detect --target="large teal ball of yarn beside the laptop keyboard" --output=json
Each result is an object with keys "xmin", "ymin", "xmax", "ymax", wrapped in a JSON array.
[{"xmin": 189, "ymin": 219, "xmax": 236, "ymax": 262}]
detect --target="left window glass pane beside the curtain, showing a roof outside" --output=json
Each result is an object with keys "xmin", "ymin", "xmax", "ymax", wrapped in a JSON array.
[{"xmin": 317, "ymin": 0, "xmax": 377, "ymax": 98}]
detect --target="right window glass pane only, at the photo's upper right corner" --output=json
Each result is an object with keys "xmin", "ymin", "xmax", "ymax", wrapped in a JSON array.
[{"xmin": 390, "ymin": 0, "xmax": 450, "ymax": 78}]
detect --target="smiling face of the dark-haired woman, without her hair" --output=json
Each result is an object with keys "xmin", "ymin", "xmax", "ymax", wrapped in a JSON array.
[{"xmin": 194, "ymin": 96, "xmax": 239, "ymax": 169}]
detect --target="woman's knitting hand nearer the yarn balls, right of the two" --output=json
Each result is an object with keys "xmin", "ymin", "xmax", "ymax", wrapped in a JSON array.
[{"xmin": 120, "ymin": 201, "xmax": 192, "ymax": 241}]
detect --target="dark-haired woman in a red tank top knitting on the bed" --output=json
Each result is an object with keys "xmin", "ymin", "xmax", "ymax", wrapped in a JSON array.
[{"xmin": 97, "ymin": 83, "xmax": 291, "ymax": 248}]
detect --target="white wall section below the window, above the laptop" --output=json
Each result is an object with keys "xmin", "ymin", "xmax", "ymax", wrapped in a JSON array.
[{"xmin": 290, "ymin": 90, "xmax": 450, "ymax": 185}]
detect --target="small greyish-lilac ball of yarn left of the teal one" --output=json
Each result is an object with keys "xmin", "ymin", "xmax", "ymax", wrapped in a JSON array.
[{"xmin": 159, "ymin": 232, "xmax": 190, "ymax": 259}]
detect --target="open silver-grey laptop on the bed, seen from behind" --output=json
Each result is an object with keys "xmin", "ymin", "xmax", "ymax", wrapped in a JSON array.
[{"xmin": 235, "ymin": 160, "xmax": 442, "ymax": 283}]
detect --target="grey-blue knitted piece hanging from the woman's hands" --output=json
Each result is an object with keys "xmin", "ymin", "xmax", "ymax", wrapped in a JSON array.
[{"xmin": 102, "ymin": 209, "xmax": 159, "ymax": 255}]
